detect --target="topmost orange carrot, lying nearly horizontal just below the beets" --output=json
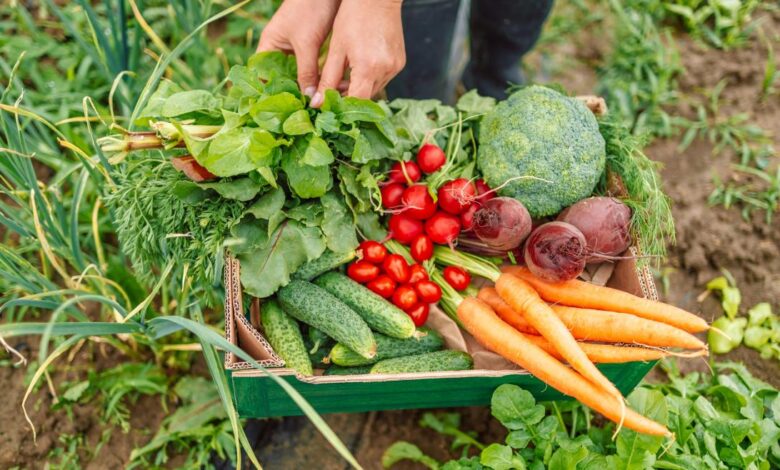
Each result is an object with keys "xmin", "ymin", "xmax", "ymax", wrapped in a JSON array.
[{"xmin": 503, "ymin": 266, "xmax": 709, "ymax": 333}]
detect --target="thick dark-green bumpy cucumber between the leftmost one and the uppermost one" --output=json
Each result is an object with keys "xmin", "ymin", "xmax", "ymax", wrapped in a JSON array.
[{"xmin": 276, "ymin": 279, "xmax": 376, "ymax": 359}]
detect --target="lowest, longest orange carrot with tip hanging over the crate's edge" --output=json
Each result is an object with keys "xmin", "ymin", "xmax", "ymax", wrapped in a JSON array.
[{"xmin": 457, "ymin": 297, "xmax": 671, "ymax": 436}]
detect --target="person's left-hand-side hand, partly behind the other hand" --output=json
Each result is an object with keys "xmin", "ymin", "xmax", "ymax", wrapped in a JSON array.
[{"xmin": 257, "ymin": 0, "xmax": 340, "ymax": 97}]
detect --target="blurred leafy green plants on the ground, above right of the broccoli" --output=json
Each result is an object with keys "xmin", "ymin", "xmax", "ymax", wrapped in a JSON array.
[{"xmin": 598, "ymin": 0, "xmax": 684, "ymax": 137}]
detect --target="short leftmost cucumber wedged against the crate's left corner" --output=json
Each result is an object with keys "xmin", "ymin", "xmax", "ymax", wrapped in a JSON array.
[{"xmin": 261, "ymin": 300, "xmax": 313, "ymax": 375}]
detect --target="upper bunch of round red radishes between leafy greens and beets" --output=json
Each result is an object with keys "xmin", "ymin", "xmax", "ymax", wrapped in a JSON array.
[{"xmin": 381, "ymin": 144, "xmax": 494, "ymax": 262}]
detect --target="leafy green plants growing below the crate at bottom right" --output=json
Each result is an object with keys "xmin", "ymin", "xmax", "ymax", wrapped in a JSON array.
[{"xmin": 382, "ymin": 362, "xmax": 780, "ymax": 470}]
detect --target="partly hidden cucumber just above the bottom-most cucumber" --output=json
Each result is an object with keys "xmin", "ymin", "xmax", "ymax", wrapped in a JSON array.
[{"xmin": 328, "ymin": 327, "xmax": 444, "ymax": 367}]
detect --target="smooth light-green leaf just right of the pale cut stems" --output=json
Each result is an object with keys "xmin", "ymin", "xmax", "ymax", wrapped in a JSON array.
[{"xmin": 201, "ymin": 127, "xmax": 258, "ymax": 177}]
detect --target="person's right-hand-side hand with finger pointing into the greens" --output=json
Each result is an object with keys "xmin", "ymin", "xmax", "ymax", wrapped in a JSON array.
[{"xmin": 311, "ymin": 0, "xmax": 406, "ymax": 108}]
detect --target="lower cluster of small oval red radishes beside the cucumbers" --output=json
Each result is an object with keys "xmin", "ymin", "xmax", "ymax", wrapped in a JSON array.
[{"xmin": 347, "ymin": 240, "xmax": 441, "ymax": 326}]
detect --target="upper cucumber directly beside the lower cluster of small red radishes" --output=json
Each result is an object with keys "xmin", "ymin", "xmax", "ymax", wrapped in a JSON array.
[{"xmin": 314, "ymin": 271, "xmax": 415, "ymax": 342}]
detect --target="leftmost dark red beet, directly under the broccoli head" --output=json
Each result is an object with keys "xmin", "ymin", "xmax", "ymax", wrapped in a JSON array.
[{"xmin": 473, "ymin": 197, "xmax": 531, "ymax": 251}]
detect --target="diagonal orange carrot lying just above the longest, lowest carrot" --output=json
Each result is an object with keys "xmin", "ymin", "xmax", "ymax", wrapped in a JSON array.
[{"xmin": 496, "ymin": 274, "xmax": 623, "ymax": 400}]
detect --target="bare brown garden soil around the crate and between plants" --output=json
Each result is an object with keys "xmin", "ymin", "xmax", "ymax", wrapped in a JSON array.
[{"xmin": 0, "ymin": 8, "xmax": 780, "ymax": 469}]
